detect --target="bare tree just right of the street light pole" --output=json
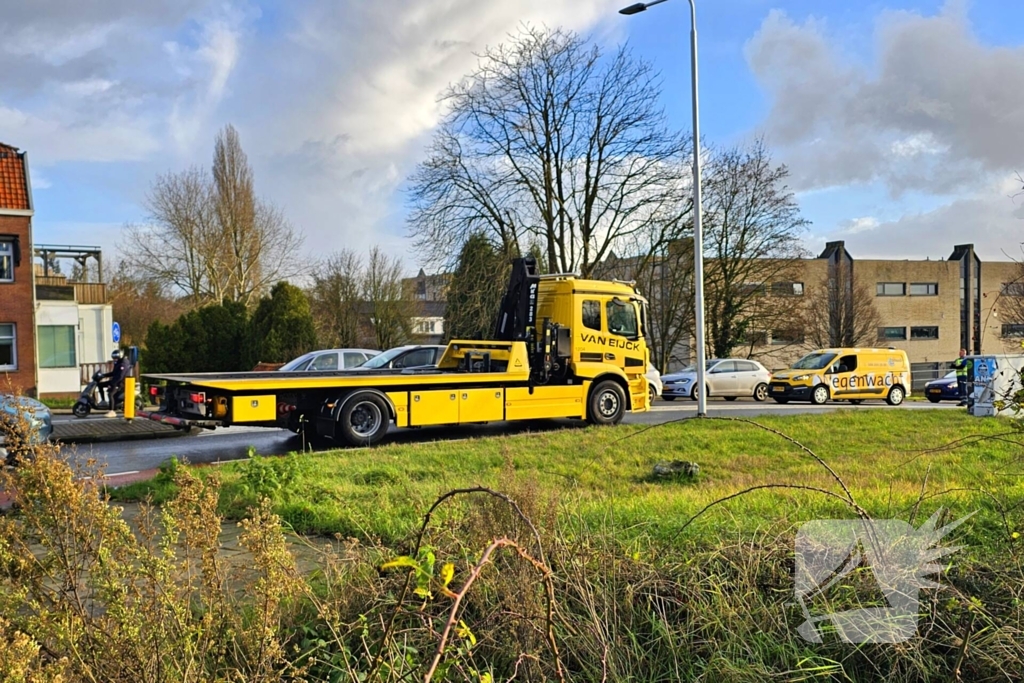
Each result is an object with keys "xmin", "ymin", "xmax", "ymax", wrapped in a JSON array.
[{"xmin": 705, "ymin": 140, "xmax": 807, "ymax": 357}]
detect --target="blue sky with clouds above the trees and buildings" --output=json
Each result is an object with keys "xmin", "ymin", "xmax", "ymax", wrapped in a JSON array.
[{"xmin": 0, "ymin": 0, "xmax": 1024, "ymax": 267}]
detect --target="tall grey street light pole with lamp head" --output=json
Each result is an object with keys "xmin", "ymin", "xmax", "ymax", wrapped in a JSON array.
[{"xmin": 618, "ymin": 0, "xmax": 708, "ymax": 418}]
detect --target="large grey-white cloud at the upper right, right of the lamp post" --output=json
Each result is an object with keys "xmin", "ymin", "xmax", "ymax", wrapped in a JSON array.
[{"xmin": 746, "ymin": 5, "xmax": 1024, "ymax": 197}]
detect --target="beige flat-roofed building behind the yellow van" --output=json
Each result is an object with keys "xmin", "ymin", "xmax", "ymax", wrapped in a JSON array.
[{"xmin": 751, "ymin": 242, "xmax": 1024, "ymax": 374}]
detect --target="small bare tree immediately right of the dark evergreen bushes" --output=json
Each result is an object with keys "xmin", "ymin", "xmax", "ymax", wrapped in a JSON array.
[{"xmin": 309, "ymin": 250, "xmax": 364, "ymax": 348}]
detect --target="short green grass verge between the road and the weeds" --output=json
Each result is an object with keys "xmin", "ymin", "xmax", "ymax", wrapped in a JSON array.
[{"xmin": 114, "ymin": 410, "xmax": 1024, "ymax": 545}]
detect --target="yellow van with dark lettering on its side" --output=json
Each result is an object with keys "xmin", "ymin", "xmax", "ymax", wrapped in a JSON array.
[{"xmin": 768, "ymin": 348, "xmax": 910, "ymax": 405}]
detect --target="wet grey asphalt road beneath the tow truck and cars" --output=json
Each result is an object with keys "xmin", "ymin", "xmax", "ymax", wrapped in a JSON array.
[{"xmin": 54, "ymin": 399, "xmax": 955, "ymax": 475}]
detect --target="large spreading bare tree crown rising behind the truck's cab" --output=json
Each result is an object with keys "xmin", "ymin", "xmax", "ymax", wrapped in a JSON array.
[{"xmin": 410, "ymin": 28, "xmax": 689, "ymax": 276}]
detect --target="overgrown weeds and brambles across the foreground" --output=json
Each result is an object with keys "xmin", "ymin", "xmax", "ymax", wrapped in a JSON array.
[{"xmin": 0, "ymin": 413, "xmax": 1024, "ymax": 683}]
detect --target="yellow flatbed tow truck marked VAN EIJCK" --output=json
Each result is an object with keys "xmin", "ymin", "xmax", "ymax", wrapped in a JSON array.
[{"xmin": 136, "ymin": 258, "xmax": 649, "ymax": 445}]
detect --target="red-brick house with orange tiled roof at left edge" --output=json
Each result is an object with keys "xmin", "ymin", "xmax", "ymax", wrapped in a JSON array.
[{"xmin": 0, "ymin": 143, "xmax": 38, "ymax": 395}]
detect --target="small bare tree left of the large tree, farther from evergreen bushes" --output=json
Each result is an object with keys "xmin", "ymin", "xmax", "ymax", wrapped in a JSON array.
[{"xmin": 361, "ymin": 247, "xmax": 417, "ymax": 349}]
